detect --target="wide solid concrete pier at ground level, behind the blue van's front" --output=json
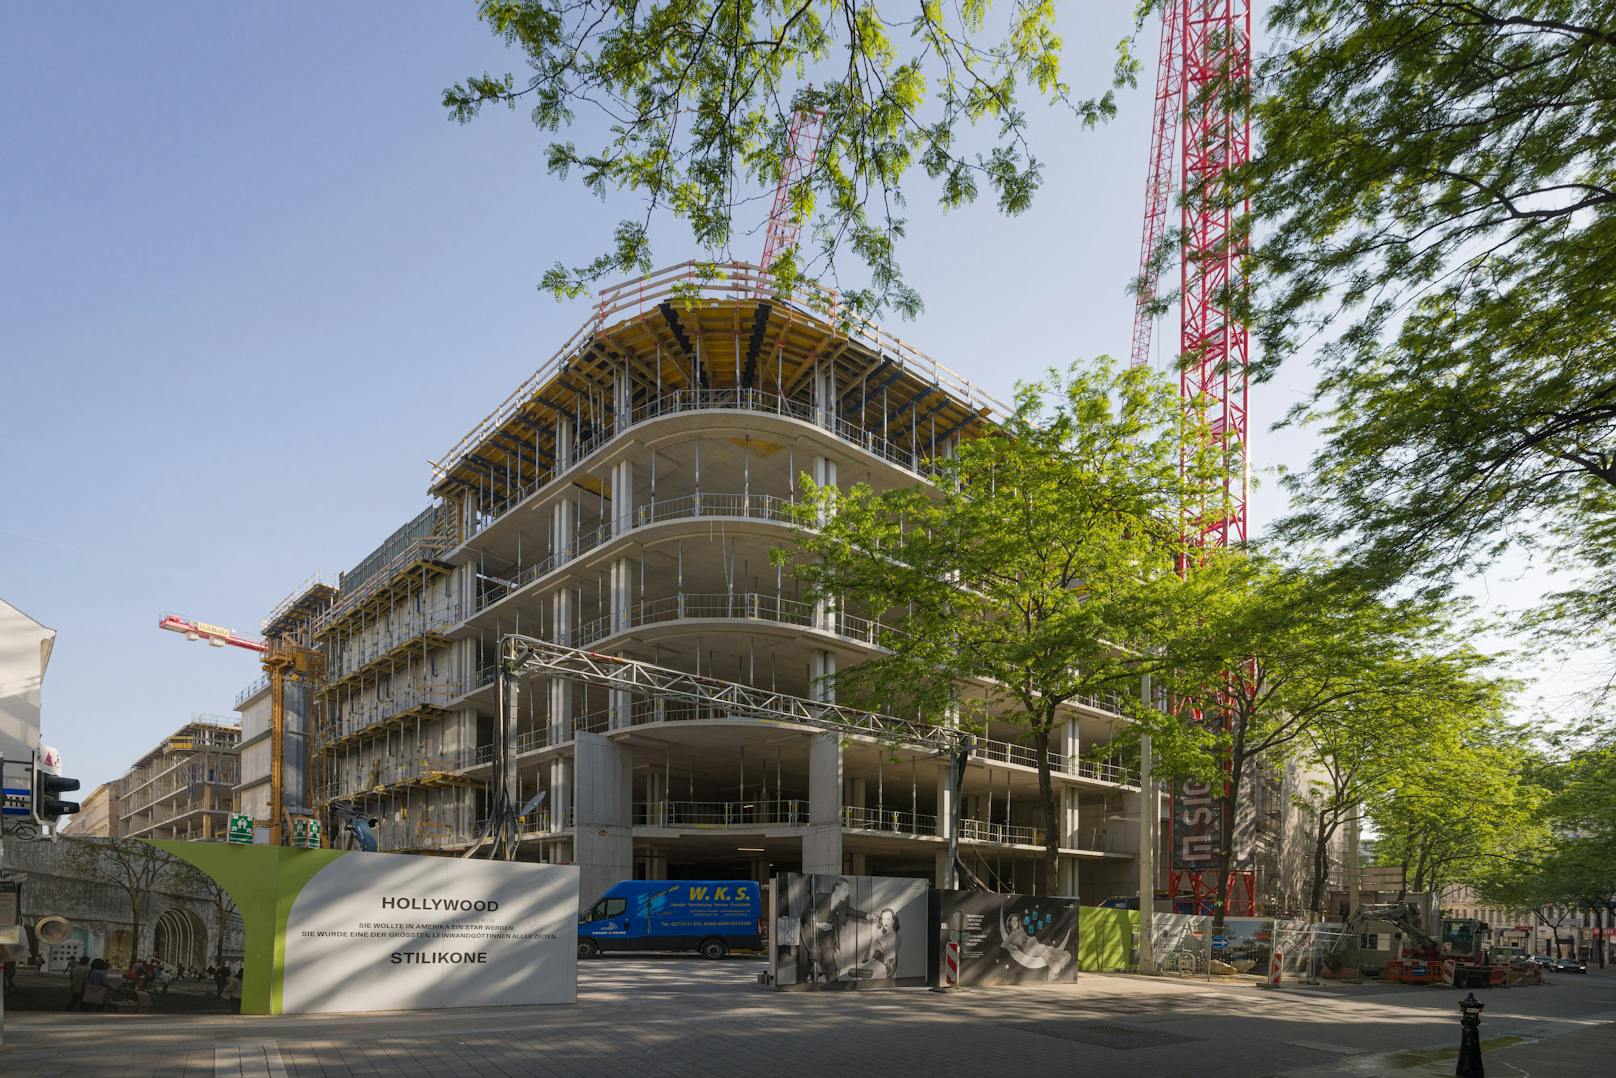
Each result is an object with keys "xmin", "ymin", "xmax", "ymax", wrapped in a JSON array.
[{"xmin": 574, "ymin": 731, "xmax": 633, "ymax": 910}]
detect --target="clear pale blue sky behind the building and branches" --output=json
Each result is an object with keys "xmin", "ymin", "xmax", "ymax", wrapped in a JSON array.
[{"xmin": 0, "ymin": 0, "xmax": 1564, "ymax": 789}]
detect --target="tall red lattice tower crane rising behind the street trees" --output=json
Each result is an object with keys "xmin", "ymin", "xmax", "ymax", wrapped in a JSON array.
[{"xmin": 1131, "ymin": 0, "xmax": 1256, "ymax": 915}]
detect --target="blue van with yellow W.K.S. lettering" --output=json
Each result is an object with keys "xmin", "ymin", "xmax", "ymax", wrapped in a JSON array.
[{"xmin": 579, "ymin": 879, "xmax": 763, "ymax": 958}]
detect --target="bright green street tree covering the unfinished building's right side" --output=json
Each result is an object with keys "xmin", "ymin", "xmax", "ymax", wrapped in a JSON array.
[{"xmin": 776, "ymin": 359, "xmax": 1207, "ymax": 894}]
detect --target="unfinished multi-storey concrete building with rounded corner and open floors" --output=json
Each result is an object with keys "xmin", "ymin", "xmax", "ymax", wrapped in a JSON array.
[{"xmin": 238, "ymin": 265, "xmax": 1141, "ymax": 903}]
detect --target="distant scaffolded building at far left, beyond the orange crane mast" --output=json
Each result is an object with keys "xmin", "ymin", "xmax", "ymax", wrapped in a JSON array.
[{"xmin": 111, "ymin": 714, "xmax": 241, "ymax": 840}]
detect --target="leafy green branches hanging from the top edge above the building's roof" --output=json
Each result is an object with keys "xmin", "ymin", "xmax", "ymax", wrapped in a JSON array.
[{"xmin": 443, "ymin": 0, "xmax": 1138, "ymax": 315}]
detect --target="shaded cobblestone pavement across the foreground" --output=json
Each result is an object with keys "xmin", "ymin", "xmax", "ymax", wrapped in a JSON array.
[{"xmin": 0, "ymin": 958, "xmax": 1616, "ymax": 1078}]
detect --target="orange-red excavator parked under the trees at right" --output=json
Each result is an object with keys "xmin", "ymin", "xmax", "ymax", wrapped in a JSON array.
[{"xmin": 1324, "ymin": 902, "xmax": 1535, "ymax": 987}]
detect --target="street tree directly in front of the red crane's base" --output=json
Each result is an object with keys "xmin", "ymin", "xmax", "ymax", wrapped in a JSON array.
[{"xmin": 1146, "ymin": 565, "xmax": 1460, "ymax": 924}]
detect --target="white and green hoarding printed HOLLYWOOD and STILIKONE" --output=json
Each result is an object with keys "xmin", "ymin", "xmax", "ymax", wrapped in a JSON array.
[{"xmin": 154, "ymin": 842, "xmax": 579, "ymax": 1013}]
